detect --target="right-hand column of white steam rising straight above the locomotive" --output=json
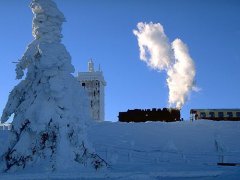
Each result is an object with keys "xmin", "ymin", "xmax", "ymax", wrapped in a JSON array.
[{"xmin": 167, "ymin": 39, "xmax": 196, "ymax": 109}]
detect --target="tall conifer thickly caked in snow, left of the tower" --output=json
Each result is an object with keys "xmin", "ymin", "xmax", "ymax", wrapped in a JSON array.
[{"xmin": 0, "ymin": 0, "xmax": 108, "ymax": 172}]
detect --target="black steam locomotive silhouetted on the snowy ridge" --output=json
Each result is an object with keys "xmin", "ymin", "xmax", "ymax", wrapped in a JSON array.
[{"xmin": 118, "ymin": 108, "xmax": 181, "ymax": 122}]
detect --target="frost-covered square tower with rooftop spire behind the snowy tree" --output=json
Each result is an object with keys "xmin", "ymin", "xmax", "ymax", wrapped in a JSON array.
[{"xmin": 77, "ymin": 59, "xmax": 106, "ymax": 121}]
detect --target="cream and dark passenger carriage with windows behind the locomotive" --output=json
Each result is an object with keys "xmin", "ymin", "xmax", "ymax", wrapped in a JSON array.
[{"xmin": 190, "ymin": 109, "xmax": 240, "ymax": 121}]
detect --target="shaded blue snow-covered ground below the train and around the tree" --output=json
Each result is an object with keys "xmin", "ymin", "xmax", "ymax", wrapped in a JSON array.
[{"xmin": 0, "ymin": 121, "xmax": 240, "ymax": 179}]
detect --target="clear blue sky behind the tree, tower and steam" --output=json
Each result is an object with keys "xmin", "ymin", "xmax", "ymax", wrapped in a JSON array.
[{"xmin": 0, "ymin": 0, "xmax": 240, "ymax": 121}]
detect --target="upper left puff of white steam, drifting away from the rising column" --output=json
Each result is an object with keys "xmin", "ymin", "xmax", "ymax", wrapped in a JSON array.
[{"xmin": 133, "ymin": 22, "xmax": 173, "ymax": 70}]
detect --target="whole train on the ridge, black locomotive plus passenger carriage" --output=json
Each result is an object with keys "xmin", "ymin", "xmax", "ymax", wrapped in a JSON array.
[{"xmin": 118, "ymin": 108, "xmax": 240, "ymax": 122}]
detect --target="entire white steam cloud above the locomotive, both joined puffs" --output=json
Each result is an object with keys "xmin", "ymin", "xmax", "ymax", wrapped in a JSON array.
[{"xmin": 133, "ymin": 22, "xmax": 196, "ymax": 109}]
